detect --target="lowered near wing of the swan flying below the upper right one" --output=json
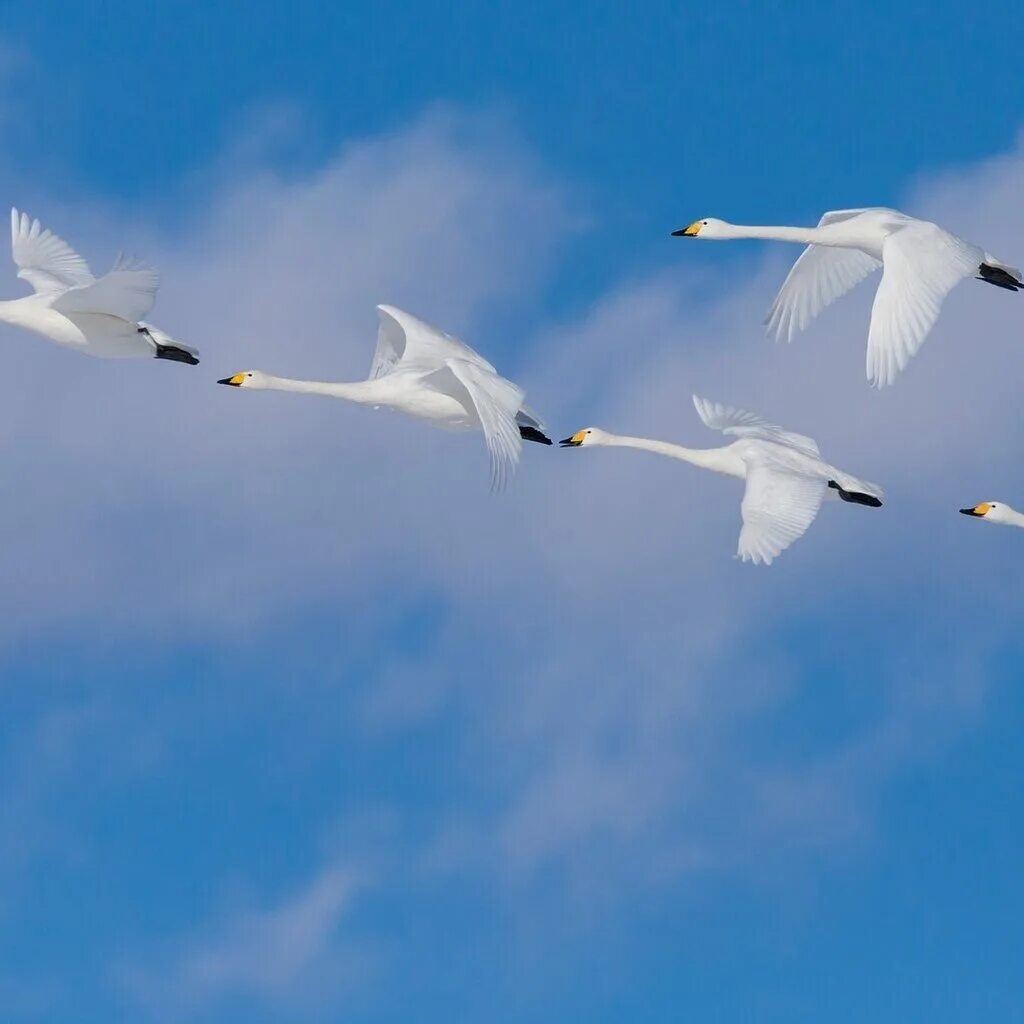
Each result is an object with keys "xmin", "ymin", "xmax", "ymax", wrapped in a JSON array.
[{"xmin": 736, "ymin": 460, "xmax": 827, "ymax": 565}]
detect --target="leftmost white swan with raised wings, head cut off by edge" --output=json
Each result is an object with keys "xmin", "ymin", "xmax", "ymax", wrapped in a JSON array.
[{"xmin": 0, "ymin": 210, "xmax": 199, "ymax": 366}]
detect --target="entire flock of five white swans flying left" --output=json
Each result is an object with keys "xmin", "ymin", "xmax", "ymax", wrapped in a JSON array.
[{"xmin": 0, "ymin": 207, "xmax": 1024, "ymax": 564}]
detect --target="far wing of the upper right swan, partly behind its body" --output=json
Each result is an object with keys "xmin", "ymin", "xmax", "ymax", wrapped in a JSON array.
[{"xmin": 765, "ymin": 208, "xmax": 882, "ymax": 341}]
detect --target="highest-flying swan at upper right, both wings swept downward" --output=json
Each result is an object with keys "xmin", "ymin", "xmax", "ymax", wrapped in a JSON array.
[{"xmin": 672, "ymin": 207, "xmax": 1024, "ymax": 387}]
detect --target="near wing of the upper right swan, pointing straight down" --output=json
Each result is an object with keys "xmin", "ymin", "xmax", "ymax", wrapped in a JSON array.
[{"xmin": 867, "ymin": 220, "xmax": 983, "ymax": 387}]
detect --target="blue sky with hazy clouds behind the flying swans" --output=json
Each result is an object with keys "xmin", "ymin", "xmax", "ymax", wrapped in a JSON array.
[{"xmin": 0, "ymin": 3, "xmax": 1024, "ymax": 1024}]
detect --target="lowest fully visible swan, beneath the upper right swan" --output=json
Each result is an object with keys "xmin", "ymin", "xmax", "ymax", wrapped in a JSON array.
[{"xmin": 559, "ymin": 395, "xmax": 882, "ymax": 565}]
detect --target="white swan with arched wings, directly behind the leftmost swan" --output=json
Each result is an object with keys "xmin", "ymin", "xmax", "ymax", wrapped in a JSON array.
[{"xmin": 217, "ymin": 306, "xmax": 551, "ymax": 490}]
